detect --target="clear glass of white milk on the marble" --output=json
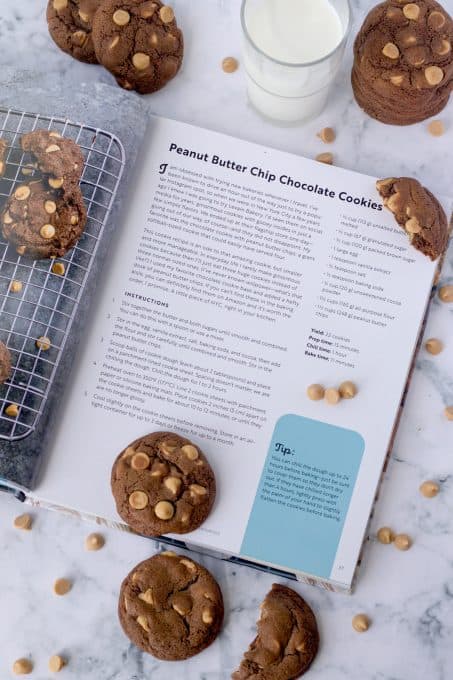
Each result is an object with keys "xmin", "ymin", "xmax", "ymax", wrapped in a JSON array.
[{"xmin": 241, "ymin": 0, "xmax": 351, "ymax": 123}]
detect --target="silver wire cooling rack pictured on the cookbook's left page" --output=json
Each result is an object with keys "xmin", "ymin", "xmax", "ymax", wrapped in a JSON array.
[{"xmin": 0, "ymin": 107, "xmax": 125, "ymax": 441}]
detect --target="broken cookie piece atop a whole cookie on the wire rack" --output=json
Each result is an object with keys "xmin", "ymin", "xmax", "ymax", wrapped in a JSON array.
[{"xmin": 20, "ymin": 130, "xmax": 84, "ymax": 189}]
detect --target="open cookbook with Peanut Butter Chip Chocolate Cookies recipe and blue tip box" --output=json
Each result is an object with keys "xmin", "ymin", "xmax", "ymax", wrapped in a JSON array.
[{"xmin": 0, "ymin": 103, "xmax": 451, "ymax": 590}]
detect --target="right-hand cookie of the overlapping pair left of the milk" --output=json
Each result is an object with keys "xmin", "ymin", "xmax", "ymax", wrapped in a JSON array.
[{"xmin": 93, "ymin": 0, "xmax": 184, "ymax": 94}]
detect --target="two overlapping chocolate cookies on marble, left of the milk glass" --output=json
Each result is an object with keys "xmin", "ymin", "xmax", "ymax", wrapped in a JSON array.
[{"xmin": 47, "ymin": 0, "xmax": 184, "ymax": 94}]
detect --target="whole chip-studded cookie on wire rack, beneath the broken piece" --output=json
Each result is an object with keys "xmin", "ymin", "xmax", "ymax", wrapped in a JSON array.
[{"xmin": 0, "ymin": 181, "xmax": 86, "ymax": 259}]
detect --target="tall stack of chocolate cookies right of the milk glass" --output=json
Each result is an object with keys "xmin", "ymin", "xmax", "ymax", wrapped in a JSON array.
[{"xmin": 352, "ymin": 0, "xmax": 453, "ymax": 125}]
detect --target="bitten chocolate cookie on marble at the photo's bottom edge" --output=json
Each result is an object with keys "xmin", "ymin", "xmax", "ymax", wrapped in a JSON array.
[{"xmin": 231, "ymin": 583, "xmax": 319, "ymax": 680}]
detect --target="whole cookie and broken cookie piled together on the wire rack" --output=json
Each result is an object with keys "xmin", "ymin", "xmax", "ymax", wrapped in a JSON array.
[{"xmin": 0, "ymin": 130, "xmax": 87, "ymax": 259}]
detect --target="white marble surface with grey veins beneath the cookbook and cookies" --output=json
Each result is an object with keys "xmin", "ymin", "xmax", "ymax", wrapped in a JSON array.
[{"xmin": 0, "ymin": 0, "xmax": 453, "ymax": 680}]
